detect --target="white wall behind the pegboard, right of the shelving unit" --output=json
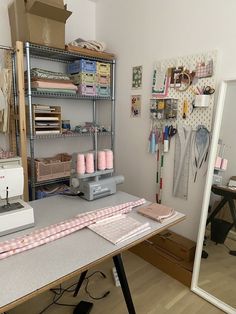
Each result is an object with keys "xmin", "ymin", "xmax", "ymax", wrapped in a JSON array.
[{"xmin": 96, "ymin": 0, "xmax": 236, "ymax": 239}]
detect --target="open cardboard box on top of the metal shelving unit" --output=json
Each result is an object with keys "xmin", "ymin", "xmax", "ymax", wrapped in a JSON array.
[{"xmin": 8, "ymin": 0, "xmax": 72, "ymax": 49}]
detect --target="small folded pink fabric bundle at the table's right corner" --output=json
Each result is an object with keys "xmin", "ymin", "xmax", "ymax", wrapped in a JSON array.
[{"xmin": 138, "ymin": 203, "xmax": 176, "ymax": 222}]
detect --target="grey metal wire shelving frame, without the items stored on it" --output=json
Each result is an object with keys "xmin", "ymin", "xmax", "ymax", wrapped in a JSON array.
[{"xmin": 24, "ymin": 42, "xmax": 116, "ymax": 200}]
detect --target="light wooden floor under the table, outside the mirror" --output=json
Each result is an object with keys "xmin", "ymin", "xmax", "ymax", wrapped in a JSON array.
[{"xmin": 7, "ymin": 252, "xmax": 223, "ymax": 314}]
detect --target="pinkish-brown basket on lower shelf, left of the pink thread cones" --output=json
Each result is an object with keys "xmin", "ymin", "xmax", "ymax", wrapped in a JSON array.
[{"xmin": 29, "ymin": 154, "xmax": 71, "ymax": 182}]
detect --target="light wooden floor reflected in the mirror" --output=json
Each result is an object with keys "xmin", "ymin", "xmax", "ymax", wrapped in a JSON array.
[{"xmin": 199, "ymin": 233, "xmax": 236, "ymax": 308}]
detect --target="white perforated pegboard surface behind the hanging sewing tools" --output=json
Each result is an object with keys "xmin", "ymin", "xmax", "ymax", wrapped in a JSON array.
[{"xmin": 151, "ymin": 51, "xmax": 217, "ymax": 131}]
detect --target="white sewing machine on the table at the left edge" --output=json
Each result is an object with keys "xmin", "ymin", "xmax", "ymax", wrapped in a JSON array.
[{"xmin": 0, "ymin": 157, "xmax": 34, "ymax": 236}]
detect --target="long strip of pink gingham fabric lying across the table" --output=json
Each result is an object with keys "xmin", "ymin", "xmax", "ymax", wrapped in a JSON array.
[{"xmin": 0, "ymin": 199, "xmax": 146, "ymax": 259}]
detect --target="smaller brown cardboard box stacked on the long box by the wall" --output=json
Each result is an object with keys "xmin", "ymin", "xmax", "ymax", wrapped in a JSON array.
[{"xmin": 149, "ymin": 230, "xmax": 196, "ymax": 262}]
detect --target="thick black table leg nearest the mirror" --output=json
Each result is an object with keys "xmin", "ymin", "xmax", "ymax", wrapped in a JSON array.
[{"xmin": 113, "ymin": 254, "xmax": 135, "ymax": 314}]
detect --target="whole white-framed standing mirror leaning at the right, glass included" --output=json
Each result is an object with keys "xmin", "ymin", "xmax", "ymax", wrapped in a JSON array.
[{"xmin": 192, "ymin": 79, "xmax": 236, "ymax": 313}]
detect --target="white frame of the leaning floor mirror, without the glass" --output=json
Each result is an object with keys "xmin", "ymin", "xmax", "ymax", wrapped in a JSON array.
[{"xmin": 191, "ymin": 78, "xmax": 236, "ymax": 314}]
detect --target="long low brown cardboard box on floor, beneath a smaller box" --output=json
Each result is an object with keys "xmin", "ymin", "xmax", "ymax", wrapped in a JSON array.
[{"xmin": 130, "ymin": 241, "xmax": 193, "ymax": 287}]
